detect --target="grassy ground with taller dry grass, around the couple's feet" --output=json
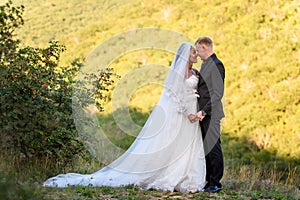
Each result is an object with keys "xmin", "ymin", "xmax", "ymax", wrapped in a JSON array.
[{"xmin": 0, "ymin": 151, "xmax": 300, "ymax": 200}]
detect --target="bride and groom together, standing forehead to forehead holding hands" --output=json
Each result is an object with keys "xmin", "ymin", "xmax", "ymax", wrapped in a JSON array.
[{"xmin": 43, "ymin": 37, "xmax": 225, "ymax": 193}]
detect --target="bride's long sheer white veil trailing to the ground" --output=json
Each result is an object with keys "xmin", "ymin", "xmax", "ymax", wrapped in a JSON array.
[{"xmin": 44, "ymin": 43, "xmax": 205, "ymax": 187}]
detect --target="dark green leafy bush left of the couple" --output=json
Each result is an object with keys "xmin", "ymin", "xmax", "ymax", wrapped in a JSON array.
[{"xmin": 0, "ymin": 1, "xmax": 116, "ymax": 170}]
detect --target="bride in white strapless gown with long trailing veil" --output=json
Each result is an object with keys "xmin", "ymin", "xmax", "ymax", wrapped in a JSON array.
[{"xmin": 43, "ymin": 43, "xmax": 206, "ymax": 192}]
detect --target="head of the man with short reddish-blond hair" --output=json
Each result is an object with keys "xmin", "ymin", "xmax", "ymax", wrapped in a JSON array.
[{"xmin": 195, "ymin": 36, "xmax": 213, "ymax": 60}]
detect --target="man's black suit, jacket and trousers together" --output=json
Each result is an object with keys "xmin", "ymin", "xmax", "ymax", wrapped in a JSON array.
[{"xmin": 197, "ymin": 54, "xmax": 225, "ymax": 188}]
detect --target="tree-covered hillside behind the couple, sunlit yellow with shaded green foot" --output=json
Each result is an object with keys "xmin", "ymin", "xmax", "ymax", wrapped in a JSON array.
[{"xmin": 0, "ymin": 0, "xmax": 300, "ymax": 199}]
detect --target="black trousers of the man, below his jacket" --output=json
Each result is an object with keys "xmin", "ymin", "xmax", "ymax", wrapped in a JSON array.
[{"xmin": 200, "ymin": 116, "xmax": 224, "ymax": 188}]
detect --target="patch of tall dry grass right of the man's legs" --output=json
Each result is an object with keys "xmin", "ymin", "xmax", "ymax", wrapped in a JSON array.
[{"xmin": 223, "ymin": 164, "xmax": 300, "ymax": 199}]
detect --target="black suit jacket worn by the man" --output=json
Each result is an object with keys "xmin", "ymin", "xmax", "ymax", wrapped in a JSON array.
[{"xmin": 197, "ymin": 54, "xmax": 225, "ymax": 119}]
